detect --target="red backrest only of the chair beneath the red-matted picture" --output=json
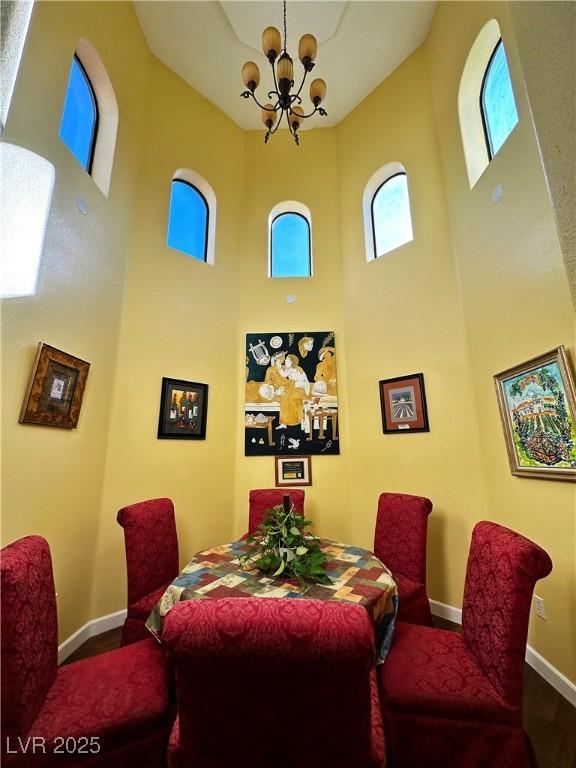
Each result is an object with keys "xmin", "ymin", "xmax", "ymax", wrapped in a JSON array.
[{"xmin": 374, "ymin": 493, "xmax": 432, "ymax": 584}]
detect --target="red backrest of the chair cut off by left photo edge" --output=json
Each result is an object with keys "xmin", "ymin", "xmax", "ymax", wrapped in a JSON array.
[{"xmin": 0, "ymin": 536, "xmax": 58, "ymax": 746}]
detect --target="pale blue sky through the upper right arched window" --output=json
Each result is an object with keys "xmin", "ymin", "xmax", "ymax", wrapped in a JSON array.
[{"xmin": 482, "ymin": 40, "xmax": 518, "ymax": 157}]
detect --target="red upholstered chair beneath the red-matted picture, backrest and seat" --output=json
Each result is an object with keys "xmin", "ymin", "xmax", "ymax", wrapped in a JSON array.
[{"xmin": 374, "ymin": 493, "xmax": 432, "ymax": 626}]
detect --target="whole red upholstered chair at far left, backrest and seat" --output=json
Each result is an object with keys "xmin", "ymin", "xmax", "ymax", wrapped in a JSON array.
[{"xmin": 0, "ymin": 536, "xmax": 171, "ymax": 768}]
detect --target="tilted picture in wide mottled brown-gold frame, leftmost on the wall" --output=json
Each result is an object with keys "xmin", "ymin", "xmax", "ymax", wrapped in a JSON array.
[{"xmin": 18, "ymin": 341, "xmax": 90, "ymax": 429}]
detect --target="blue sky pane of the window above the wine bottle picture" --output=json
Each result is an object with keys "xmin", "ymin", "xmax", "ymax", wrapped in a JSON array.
[{"xmin": 166, "ymin": 179, "xmax": 208, "ymax": 261}]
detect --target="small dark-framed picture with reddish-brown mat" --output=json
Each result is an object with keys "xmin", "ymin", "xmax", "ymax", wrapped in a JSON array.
[{"xmin": 379, "ymin": 373, "xmax": 430, "ymax": 434}]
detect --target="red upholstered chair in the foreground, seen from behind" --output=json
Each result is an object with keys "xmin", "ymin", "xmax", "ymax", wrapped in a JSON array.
[{"xmin": 162, "ymin": 598, "xmax": 385, "ymax": 768}]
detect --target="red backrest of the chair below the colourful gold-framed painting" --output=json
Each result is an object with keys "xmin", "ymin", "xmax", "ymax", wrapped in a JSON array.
[{"xmin": 462, "ymin": 522, "xmax": 552, "ymax": 706}]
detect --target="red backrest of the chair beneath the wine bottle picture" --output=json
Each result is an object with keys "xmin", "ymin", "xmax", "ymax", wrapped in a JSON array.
[{"xmin": 117, "ymin": 499, "xmax": 179, "ymax": 605}]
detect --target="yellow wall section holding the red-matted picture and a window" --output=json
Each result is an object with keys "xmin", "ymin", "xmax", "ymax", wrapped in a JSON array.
[{"xmin": 337, "ymin": 43, "xmax": 487, "ymax": 616}]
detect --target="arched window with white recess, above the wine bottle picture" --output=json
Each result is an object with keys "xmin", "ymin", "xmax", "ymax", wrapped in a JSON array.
[{"xmin": 166, "ymin": 169, "xmax": 216, "ymax": 264}]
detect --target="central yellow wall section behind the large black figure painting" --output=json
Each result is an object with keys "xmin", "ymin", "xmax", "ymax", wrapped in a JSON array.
[{"xmin": 234, "ymin": 129, "xmax": 350, "ymax": 539}]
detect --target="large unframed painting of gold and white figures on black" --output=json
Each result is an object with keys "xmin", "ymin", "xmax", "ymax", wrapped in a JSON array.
[{"xmin": 244, "ymin": 331, "xmax": 340, "ymax": 456}]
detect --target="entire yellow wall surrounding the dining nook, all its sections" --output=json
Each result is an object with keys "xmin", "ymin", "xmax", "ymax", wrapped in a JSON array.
[{"xmin": 2, "ymin": 2, "xmax": 576, "ymax": 680}]
